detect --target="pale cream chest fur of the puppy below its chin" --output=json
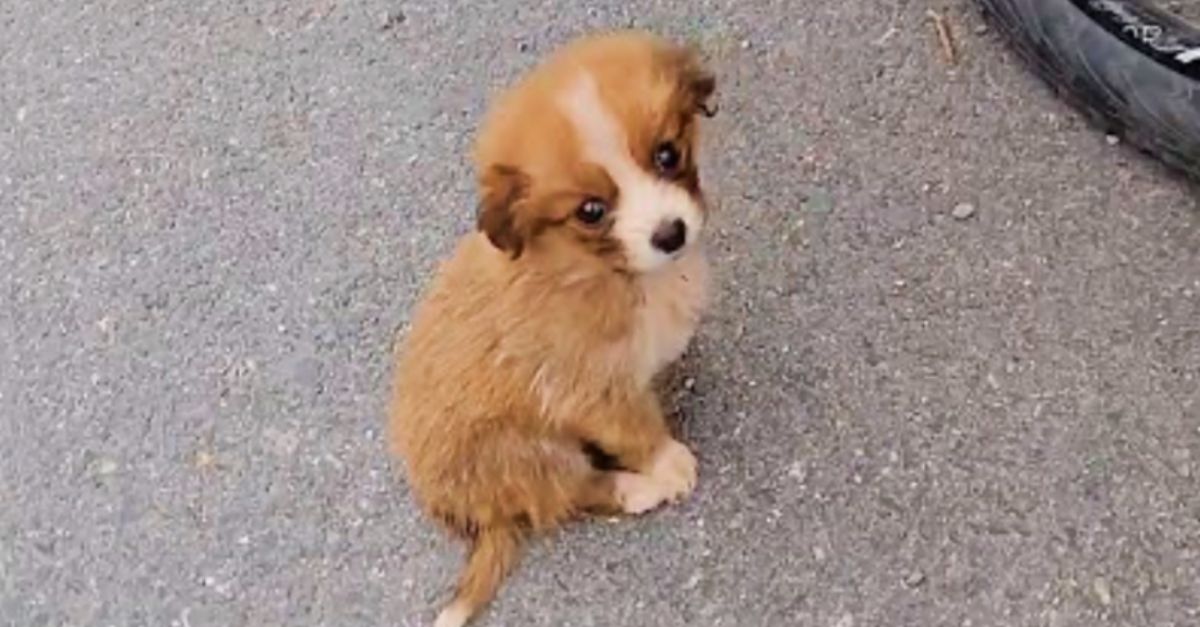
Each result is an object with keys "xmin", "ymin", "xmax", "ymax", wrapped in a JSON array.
[{"xmin": 629, "ymin": 247, "xmax": 709, "ymax": 386}]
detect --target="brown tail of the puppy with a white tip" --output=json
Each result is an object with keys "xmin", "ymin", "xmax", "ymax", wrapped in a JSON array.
[{"xmin": 433, "ymin": 527, "xmax": 521, "ymax": 627}]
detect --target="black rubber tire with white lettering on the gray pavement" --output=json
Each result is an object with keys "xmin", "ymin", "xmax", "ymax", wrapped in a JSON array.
[{"xmin": 977, "ymin": 0, "xmax": 1200, "ymax": 181}]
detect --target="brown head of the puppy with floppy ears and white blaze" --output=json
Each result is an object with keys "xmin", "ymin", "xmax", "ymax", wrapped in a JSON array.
[{"xmin": 475, "ymin": 32, "xmax": 715, "ymax": 274}]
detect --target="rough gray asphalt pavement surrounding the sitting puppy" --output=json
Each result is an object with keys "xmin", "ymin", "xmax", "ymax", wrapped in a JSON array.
[{"xmin": 0, "ymin": 0, "xmax": 1200, "ymax": 627}]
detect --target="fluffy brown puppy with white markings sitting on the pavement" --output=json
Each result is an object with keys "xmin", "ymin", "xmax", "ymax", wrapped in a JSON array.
[{"xmin": 389, "ymin": 32, "xmax": 714, "ymax": 627}]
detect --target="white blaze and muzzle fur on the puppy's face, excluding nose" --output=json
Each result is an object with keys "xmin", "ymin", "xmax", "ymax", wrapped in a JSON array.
[{"xmin": 558, "ymin": 73, "xmax": 704, "ymax": 273}]
